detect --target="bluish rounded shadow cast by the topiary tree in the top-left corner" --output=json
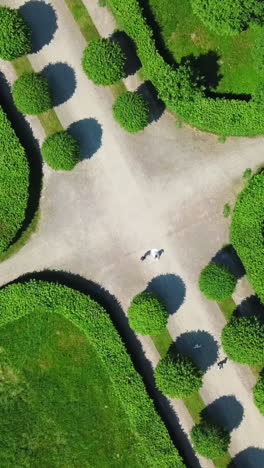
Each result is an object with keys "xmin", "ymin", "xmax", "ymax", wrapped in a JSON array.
[{"xmin": 19, "ymin": 0, "xmax": 58, "ymax": 53}]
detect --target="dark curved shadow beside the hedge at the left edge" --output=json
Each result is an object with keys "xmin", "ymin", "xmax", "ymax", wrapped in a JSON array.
[{"xmin": 0, "ymin": 72, "xmax": 43, "ymax": 249}]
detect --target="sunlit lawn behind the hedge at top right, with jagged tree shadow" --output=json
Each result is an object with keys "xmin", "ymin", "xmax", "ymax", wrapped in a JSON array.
[{"xmin": 149, "ymin": 0, "xmax": 263, "ymax": 94}]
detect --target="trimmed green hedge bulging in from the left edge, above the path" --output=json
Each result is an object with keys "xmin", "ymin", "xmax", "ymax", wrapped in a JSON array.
[{"xmin": 0, "ymin": 107, "xmax": 29, "ymax": 252}]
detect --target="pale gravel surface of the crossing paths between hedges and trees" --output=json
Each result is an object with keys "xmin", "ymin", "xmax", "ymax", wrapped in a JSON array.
[{"xmin": 0, "ymin": 0, "xmax": 264, "ymax": 467}]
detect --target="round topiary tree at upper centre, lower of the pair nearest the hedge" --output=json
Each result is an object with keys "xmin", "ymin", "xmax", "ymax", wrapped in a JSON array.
[{"xmin": 113, "ymin": 91, "xmax": 149, "ymax": 133}]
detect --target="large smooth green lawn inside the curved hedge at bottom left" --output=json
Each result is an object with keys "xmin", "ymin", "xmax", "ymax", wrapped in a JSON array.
[{"xmin": 0, "ymin": 310, "xmax": 144, "ymax": 468}]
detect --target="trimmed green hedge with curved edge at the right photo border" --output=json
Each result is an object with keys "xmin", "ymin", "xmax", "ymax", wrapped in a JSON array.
[{"xmin": 230, "ymin": 171, "xmax": 264, "ymax": 303}]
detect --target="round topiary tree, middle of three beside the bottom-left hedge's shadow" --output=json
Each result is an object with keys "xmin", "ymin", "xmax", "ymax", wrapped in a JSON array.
[{"xmin": 154, "ymin": 351, "xmax": 203, "ymax": 398}]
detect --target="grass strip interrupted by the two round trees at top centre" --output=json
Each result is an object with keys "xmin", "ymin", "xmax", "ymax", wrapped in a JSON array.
[{"xmin": 64, "ymin": 0, "xmax": 126, "ymax": 98}]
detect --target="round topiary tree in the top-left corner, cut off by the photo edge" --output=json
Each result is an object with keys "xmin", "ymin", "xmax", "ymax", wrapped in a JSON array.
[{"xmin": 0, "ymin": 6, "xmax": 32, "ymax": 60}]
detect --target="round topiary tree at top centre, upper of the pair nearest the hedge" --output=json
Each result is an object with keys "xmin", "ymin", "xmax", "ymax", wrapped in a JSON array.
[{"xmin": 82, "ymin": 39, "xmax": 126, "ymax": 86}]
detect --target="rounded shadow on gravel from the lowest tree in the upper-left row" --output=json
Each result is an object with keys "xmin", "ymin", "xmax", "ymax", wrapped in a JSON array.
[{"xmin": 68, "ymin": 118, "xmax": 103, "ymax": 159}]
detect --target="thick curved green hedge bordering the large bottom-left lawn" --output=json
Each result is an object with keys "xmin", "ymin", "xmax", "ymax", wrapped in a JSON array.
[{"xmin": 0, "ymin": 279, "xmax": 185, "ymax": 468}]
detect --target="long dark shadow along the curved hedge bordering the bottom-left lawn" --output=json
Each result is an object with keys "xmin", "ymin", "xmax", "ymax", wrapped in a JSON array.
[{"xmin": 0, "ymin": 270, "xmax": 200, "ymax": 468}]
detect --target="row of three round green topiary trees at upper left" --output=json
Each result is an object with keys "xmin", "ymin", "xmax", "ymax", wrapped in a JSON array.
[{"xmin": 0, "ymin": 6, "xmax": 81, "ymax": 170}]
